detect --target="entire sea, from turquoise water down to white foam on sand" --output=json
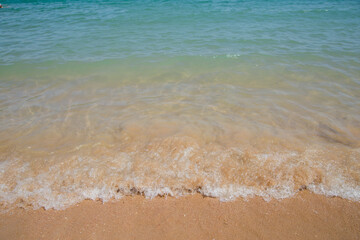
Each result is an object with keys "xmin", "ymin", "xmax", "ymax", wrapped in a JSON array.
[{"xmin": 0, "ymin": 1, "xmax": 360, "ymax": 209}]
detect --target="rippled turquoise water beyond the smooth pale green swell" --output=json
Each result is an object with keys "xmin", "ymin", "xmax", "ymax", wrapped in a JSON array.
[{"xmin": 0, "ymin": 1, "xmax": 360, "ymax": 64}]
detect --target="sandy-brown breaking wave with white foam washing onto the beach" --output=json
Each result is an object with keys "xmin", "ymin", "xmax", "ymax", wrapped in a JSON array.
[{"xmin": 0, "ymin": 137, "xmax": 360, "ymax": 212}]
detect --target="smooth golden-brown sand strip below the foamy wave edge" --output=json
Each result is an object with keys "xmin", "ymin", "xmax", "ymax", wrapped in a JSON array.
[{"xmin": 0, "ymin": 190, "xmax": 360, "ymax": 239}]
